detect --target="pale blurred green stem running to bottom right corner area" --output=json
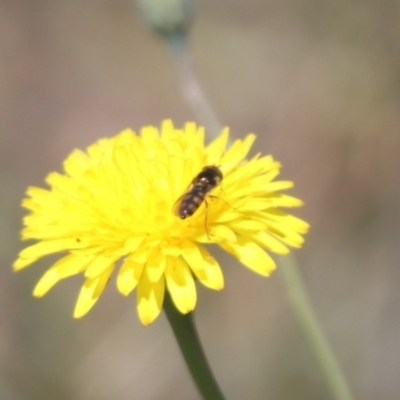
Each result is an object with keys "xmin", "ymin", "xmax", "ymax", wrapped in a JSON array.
[{"xmin": 279, "ymin": 254, "xmax": 354, "ymax": 400}]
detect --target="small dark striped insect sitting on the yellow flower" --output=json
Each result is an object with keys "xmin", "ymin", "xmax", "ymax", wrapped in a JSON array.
[{"xmin": 175, "ymin": 165, "xmax": 223, "ymax": 219}]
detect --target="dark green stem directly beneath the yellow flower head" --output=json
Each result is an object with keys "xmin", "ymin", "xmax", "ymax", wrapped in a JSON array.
[{"xmin": 164, "ymin": 292, "xmax": 224, "ymax": 400}]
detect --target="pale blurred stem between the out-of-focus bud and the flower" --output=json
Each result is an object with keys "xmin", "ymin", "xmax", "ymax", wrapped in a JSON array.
[{"xmin": 167, "ymin": 32, "xmax": 221, "ymax": 137}]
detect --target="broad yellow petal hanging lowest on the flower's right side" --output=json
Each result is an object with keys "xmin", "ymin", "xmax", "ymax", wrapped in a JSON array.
[{"xmin": 219, "ymin": 239, "xmax": 276, "ymax": 276}]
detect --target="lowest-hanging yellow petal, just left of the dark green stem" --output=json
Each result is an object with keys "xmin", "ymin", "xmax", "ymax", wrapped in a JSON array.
[{"xmin": 137, "ymin": 272, "xmax": 165, "ymax": 325}]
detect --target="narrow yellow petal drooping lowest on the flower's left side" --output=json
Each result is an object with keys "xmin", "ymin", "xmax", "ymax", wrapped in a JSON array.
[{"xmin": 74, "ymin": 267, "xmax": 114, "ymax": 318}]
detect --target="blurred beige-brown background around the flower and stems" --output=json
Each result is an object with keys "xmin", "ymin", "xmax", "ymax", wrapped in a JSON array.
[{"xmin": 0, "ymin": 0, "xmax": 400, "ymax": 400}]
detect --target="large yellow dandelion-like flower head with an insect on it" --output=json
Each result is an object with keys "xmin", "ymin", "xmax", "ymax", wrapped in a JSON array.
[{"xmin": 14, "ymin": 121, "xmax": 308, "ymax": 325}]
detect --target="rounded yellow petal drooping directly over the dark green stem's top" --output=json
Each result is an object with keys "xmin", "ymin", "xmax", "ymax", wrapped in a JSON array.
[{"xmin": 165, "ymin": 257, "xmax": 197, "ymax": 314}]
